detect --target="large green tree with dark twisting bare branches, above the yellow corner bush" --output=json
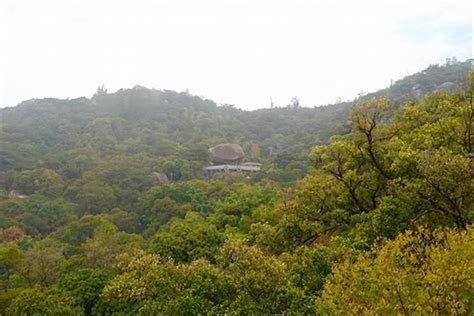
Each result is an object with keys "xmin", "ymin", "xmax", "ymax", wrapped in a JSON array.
[{"xmin": 274, "ymin": 84, "xmax": 474, "ymax": 250}]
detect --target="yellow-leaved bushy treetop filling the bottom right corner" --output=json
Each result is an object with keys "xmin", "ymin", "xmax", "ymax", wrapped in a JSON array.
[{"xmin": 318, "ymin": 228, "xmax": 474, "ymax": 315}]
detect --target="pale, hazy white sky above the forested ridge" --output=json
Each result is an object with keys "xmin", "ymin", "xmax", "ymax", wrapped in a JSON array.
[{"xmin": 0, "ymin": 0, "xmax": 473, "ymax": 109}]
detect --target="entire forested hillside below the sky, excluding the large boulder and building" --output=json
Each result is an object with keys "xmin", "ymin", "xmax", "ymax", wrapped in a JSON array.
[{"xmin": 0, "ymin": 61, "xmax": 474, "ymax": 315}]
